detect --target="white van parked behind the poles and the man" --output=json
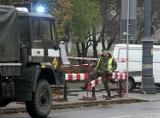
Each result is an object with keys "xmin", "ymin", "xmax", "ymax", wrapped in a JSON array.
[{"xmin": 113, "ymin": 44, "xmax": 160, "ymax": 91}]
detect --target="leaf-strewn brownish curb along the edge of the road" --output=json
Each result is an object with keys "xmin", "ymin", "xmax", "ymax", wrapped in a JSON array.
[{"xmin": 0, "ymin": 99, "xmax": 148, "ymax": 114}]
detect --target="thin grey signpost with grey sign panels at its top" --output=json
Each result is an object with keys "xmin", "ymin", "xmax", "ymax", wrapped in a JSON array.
[{"xmin": 120, "ymin": 0, "xmax": 137, "ymax": 96}]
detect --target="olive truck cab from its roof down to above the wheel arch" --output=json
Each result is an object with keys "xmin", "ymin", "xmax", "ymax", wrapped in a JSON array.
[{"xmin": 18, "ymin": 12, "xmax": 60, "ymax": 69}]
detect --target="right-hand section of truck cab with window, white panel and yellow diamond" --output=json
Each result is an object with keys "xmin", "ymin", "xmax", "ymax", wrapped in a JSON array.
[{"xmin": 41, "ymin": 19, "xmax": 60, "ymax": 69}]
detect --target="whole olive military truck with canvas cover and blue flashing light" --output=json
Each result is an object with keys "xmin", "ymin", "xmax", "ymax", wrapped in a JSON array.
[{"xmin": 0, "ymin": 5, "xmax": 61, "ymax": 118}]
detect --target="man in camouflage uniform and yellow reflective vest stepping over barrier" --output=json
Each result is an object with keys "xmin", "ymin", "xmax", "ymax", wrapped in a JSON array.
[{"xmin": 82, "ymin": 49, "xmax": 117, "ymax": 99}]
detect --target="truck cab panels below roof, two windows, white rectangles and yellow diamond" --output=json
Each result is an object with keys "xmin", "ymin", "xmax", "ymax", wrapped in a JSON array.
[{"xmin": 31, "ymin": 17, "xmax": 60, "ymax": 69}]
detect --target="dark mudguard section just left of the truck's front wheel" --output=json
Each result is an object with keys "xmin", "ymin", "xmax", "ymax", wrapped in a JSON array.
[{"xmin": 16, "ymin": 65, "xmax": 41, "ymax": 101}]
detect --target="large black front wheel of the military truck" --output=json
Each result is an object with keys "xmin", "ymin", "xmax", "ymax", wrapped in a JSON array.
[{"xmin": 26, "ymin": 80, "xmax": 52, "ymax": 118}]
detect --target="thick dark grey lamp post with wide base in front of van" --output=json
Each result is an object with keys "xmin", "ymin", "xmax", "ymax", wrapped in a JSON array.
[{"xmin": 141, "ymin": 0, "xmax": 156, "ymax": 94}]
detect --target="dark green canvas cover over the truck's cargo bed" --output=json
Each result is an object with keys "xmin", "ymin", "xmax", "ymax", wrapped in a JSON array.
[{"xmin": 0, "ymin": 5, "xmax": 20, "ymax": 62}]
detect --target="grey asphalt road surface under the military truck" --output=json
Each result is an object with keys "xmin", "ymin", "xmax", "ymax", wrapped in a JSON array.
[{"xmin": 0, "ymin": 102, "xmax": 160, "ymax": 118}]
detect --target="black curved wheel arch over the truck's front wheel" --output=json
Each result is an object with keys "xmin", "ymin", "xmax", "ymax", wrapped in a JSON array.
[{"xmin": 16, "ymin": 63, "xmax": 57, "ymax": 97}]
